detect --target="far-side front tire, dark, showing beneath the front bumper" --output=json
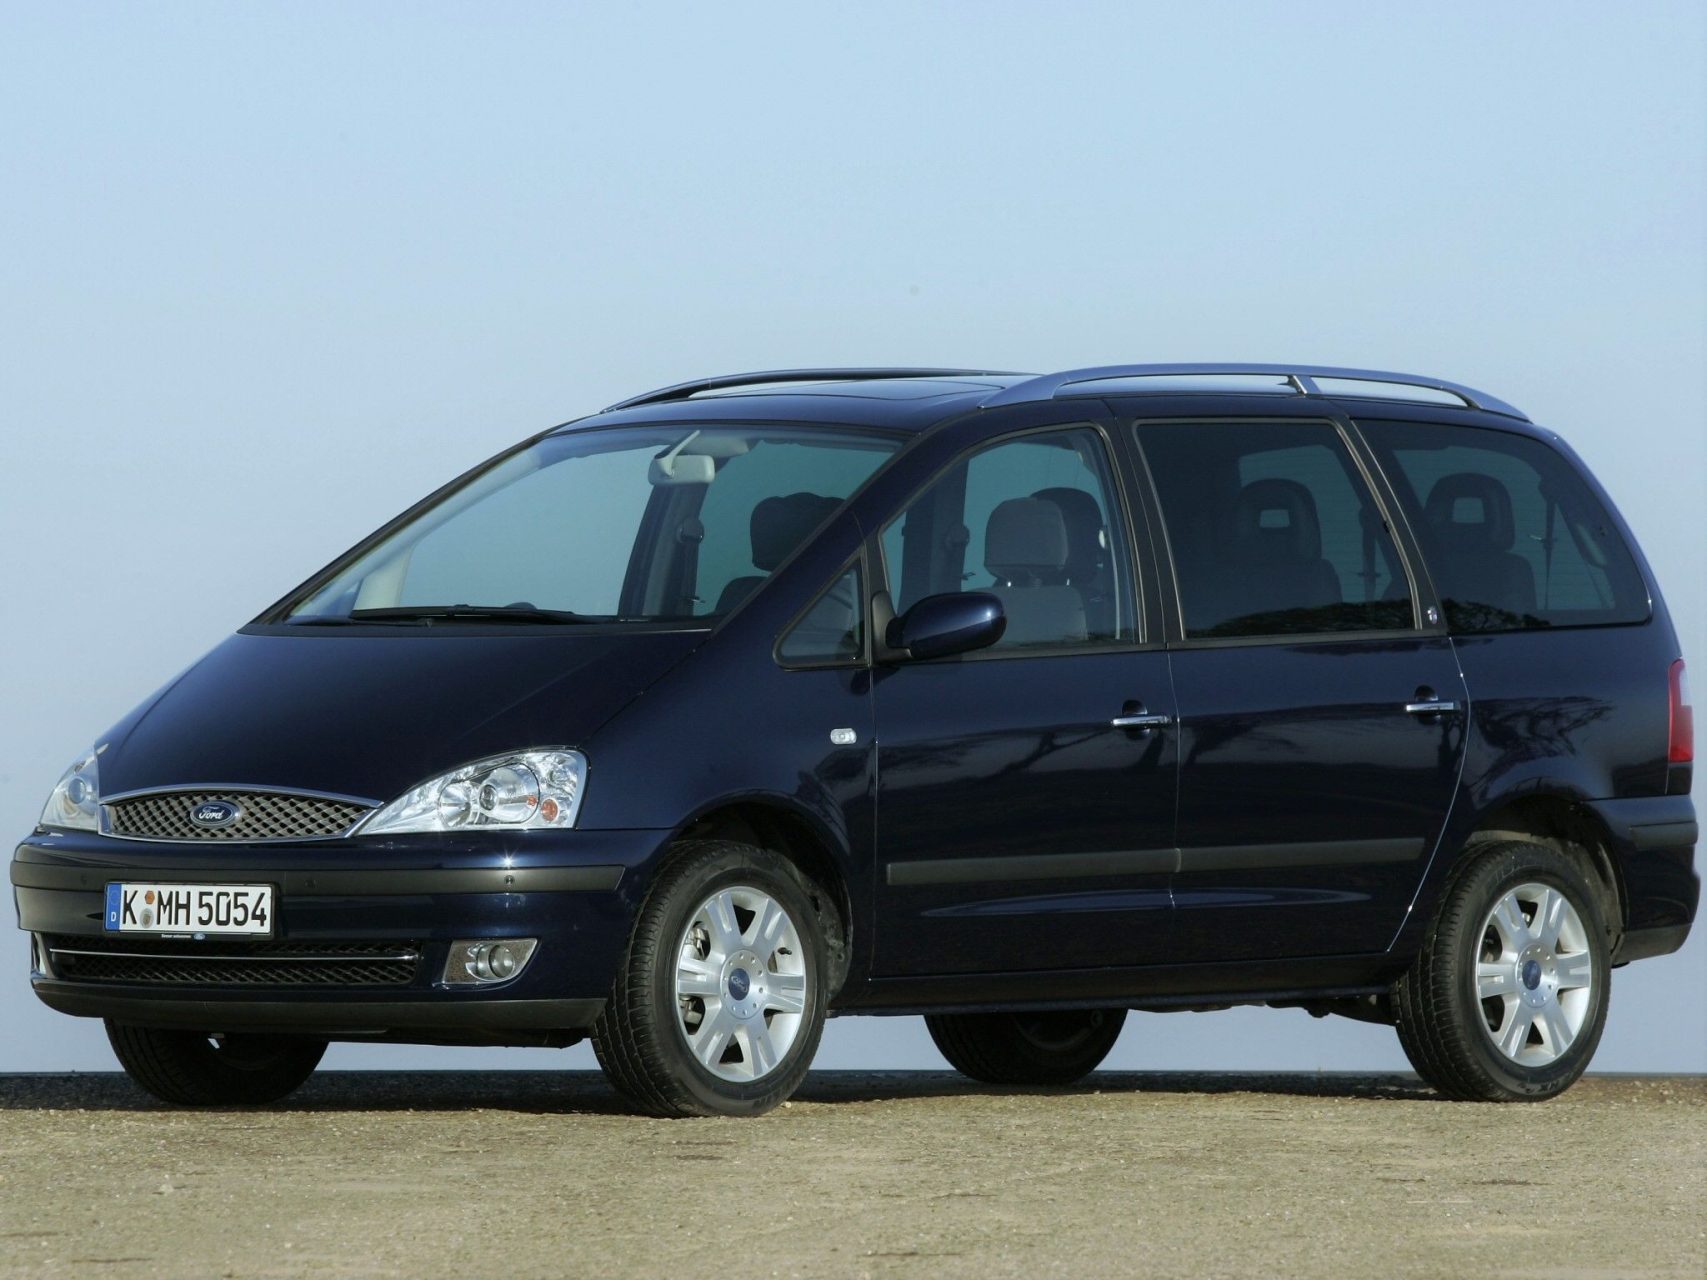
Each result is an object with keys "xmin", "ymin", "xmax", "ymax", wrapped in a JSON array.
[{"xmin": 106, "ymin": 1021, "xmax": 326, "ymax": 1106}]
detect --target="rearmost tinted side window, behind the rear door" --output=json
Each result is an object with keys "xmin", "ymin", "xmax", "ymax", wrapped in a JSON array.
[{"xmin": 1362, "ymin": 422, "xmax": 1649, "ymax": 631}]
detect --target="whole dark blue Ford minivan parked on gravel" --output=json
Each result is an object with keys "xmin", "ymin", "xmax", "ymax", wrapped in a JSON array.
[{"xmin": 12, "ymin": 365, "xmax": 1700, "ymax": 1116}]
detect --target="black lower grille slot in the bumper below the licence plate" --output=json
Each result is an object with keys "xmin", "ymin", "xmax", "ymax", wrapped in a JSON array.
[{"xmin": 46, "ymin": 934, "xmax": 422, "ymax": 986}]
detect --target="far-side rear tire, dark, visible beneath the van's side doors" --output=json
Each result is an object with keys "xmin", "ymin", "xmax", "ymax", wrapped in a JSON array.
[{"xmin": 925, "ymin": 1009, "xmax": 1127, "ymax": 1085}]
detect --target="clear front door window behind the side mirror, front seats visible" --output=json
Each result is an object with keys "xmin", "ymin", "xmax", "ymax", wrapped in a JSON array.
[{"xmin": 883, "ymin": 427, "xmax": 1135, "ymax": 649}]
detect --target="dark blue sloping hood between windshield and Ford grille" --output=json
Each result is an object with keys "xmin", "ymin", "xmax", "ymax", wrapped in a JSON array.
[{"xmin": 101, "ymin": 628, "xmax": 705, "ymax": 802}]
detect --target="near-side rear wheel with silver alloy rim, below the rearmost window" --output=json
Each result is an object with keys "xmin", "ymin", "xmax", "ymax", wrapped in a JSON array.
[{"xmin": 1393, "ymin": 840, "xmax": 1611, "ymax": 1103}]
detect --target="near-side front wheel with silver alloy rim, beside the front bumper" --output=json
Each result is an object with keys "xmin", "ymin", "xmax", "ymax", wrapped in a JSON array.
[{"xmin": 592, "ymin": 840, "xmax": 828, "ymax": 1116}]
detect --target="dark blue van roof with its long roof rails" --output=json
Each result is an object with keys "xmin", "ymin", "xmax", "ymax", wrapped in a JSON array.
[{"xmin": 560, "ymin": 364, "xmax": 1552, "ymax": 435}]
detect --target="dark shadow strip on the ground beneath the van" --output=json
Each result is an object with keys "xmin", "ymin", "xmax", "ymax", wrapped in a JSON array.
[{"xmin": 0, "ymin": 1072, "xmax": 1437, "ymax": 1114}]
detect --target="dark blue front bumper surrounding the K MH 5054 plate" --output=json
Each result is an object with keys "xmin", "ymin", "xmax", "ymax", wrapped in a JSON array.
[{"xmin": 12, "ymin": 831, "xmax": 671, "ymax": 1044}]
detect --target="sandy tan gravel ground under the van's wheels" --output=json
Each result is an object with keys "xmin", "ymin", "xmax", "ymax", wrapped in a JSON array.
[{"xmin": 0, "ymin": 1072, "xmax": 1707, "ymax": 1280}]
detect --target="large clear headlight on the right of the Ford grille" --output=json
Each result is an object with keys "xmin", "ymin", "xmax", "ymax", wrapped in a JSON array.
[{"xmin": 355, "ymin": 748, "xmax": 587, "ymax": 836}]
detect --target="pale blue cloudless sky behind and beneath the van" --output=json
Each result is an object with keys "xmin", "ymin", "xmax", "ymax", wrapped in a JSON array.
[{"xmin": 0, "ymin": 0, "xmax": 1707, "ymax": 1070}]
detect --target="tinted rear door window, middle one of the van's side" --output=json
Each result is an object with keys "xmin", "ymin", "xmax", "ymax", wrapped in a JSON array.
[{"xmin": 1139, "ymin": 423, "xmax": 1413, "ymax": 637}]
